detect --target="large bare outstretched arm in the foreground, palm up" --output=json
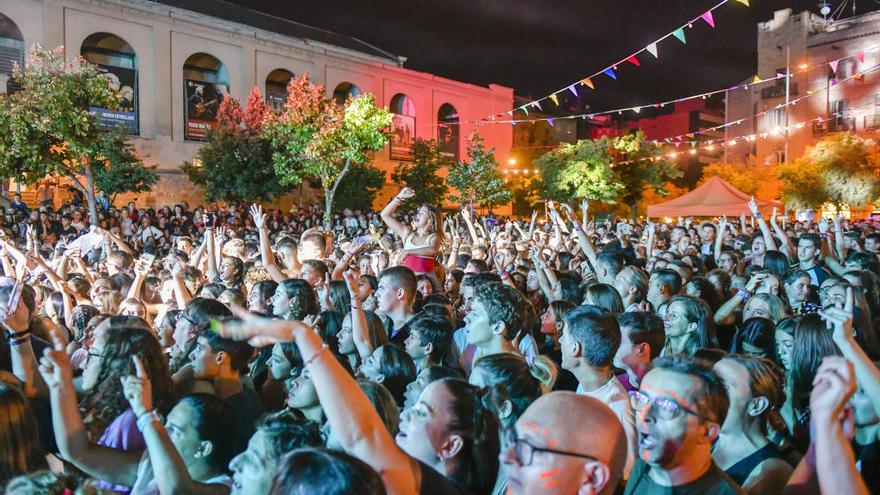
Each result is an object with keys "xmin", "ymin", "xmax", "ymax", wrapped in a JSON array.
[{"xmin": 214, "ymin": 311, "xmax": 417, "ymax": 495}]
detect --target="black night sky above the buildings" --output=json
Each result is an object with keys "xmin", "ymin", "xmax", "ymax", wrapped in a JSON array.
[{"xmin": 225, "ymin": 0, "xmax": 880, "ymax": 111}]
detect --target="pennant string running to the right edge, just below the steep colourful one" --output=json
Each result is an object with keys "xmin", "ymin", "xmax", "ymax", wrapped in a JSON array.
[{"xmin": 470, "ymin": 45, "xmax": 880, "ymax": 126}]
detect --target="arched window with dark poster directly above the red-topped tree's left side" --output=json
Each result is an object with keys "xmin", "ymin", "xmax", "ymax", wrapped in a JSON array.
[{"xmin": 183, "ymin": 53, "xmax": 229, "ymax": 141}]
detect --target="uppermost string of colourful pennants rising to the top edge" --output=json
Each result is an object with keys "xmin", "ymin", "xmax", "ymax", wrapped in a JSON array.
[{"xmin": 472, "ymin": 0, "xmax": 749, "ymax": 123}]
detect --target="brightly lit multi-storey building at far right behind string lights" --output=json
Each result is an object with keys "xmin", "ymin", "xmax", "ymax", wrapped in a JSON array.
[{"xmin": 725, "ymin": 9, "xmax": 880, "ymax": 165}]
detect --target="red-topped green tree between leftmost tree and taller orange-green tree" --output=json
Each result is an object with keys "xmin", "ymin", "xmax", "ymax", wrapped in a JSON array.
[{"xmin": 180, "ymin": 88, "xmax": 285, "ymax": 203}]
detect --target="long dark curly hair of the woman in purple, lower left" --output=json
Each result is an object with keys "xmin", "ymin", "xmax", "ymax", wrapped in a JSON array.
[{"xmin": 80, "ymin": 322, "xmax": 176, "ymax": 440}]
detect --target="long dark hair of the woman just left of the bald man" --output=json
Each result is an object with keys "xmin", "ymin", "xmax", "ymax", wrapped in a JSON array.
[{"xmin": 439, "ymin": 378, "xmax": 501, "ymax": 493}]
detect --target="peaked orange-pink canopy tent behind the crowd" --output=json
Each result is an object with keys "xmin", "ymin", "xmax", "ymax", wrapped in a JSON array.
[{"xmin": 648, "ymin": 176, "xmax": 784, "ymax": 217}]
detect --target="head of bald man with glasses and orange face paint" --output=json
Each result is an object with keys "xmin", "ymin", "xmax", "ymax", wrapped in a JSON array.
[{"xmin": 501, "ymin": 392, "xmax": 626, "ymax": 495}]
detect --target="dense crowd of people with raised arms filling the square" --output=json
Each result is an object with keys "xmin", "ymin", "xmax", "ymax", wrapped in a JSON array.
[{"xmin": 0, "ymin": 188, "xmax": 880, "ymax": 495}]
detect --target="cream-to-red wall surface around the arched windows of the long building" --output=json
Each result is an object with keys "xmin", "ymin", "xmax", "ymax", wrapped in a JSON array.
[{"xmin": 0, "ymin": 0, "xmax": 513, "ymax": 210}]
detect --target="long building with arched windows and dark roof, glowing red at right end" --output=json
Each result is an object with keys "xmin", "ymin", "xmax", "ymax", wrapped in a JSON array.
[{"xmin": 0, "ymin": 0, "xmax": 513, "ymax": 206}]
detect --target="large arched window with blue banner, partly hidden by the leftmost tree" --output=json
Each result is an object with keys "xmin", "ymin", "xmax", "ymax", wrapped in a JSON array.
[{"xmin": 80, "ymin": 33, "xmax": 138, "ymax": 135}]
